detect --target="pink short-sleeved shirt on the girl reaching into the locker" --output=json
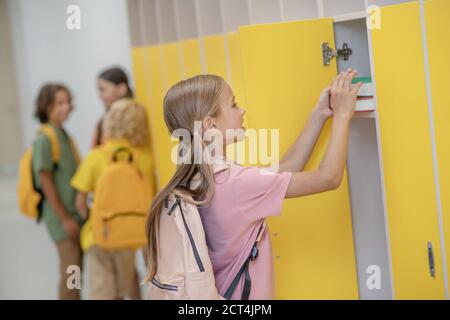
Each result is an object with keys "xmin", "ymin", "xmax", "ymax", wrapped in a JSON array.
[{"xmin": 199, "ymin": 164, "xmax": 292, "ymax": 300}]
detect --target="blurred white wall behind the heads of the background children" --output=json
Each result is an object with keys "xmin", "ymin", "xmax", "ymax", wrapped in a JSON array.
[{"xmin": 8, "ymin": 0, "xmax": 131, "ymax": 154}]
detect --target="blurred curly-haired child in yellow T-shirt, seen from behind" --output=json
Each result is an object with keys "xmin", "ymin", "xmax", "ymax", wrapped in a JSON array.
[{"xmin": 72, "ymin": 98, "xmax": 153, "ymax": 300}]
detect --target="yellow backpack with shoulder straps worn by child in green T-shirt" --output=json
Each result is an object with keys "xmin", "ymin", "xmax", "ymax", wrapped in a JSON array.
[{"xmin": 17, "ymin": 124, "xmax": 80, "ymax": 221}]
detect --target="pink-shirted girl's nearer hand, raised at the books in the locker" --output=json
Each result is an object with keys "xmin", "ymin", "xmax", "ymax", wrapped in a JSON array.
[{"xmin": 331, "ymin": 69, "xmax": 362, "ymax": 118}]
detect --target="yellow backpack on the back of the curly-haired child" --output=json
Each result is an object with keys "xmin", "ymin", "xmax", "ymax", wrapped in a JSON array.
[{"xmin": 91, "ymin": 148, "xmax": 152, "ymax": 250}]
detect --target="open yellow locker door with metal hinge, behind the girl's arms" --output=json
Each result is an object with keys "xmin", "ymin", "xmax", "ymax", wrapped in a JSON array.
[{"xmin": 239, "ymin": 19, "xmax": 358, "ymax": 299}]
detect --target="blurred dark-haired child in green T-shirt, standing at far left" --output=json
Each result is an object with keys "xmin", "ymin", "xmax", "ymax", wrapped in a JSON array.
[{"xmin": 32, "ymin": 84, "xmax": 83, "ymax": 299}]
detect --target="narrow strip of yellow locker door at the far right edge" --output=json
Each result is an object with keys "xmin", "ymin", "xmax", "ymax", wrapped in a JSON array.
[{"xmin": 424, "ymin": 0, "xmax": 450, "ymax": 292}]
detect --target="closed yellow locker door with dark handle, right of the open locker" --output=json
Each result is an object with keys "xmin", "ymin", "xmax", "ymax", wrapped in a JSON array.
[{"xmin": 372, "ymin": 2, "xmax": 444, "ymax": 299}]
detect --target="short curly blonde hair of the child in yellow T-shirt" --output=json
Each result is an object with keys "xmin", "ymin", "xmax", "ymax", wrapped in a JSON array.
[{"xmin": 102, "ymin": 98, "xmax": 149, "ymax": 147}]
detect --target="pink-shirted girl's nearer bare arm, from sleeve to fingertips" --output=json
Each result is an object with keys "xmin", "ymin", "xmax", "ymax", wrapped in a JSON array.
[{"xmin": 286, "ymin": 69, "xmax": 362, "ymax": 198}]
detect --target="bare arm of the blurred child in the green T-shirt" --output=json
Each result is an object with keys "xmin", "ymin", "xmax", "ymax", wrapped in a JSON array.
[{"xmin": 39, "ymin": 170, "xmax": 80, "ymax": 241}]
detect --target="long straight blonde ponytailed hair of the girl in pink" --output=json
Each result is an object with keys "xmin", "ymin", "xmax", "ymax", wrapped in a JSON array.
[{"xmin": 145, "ymin": 75, "xmax": 226, "ymax": 282}]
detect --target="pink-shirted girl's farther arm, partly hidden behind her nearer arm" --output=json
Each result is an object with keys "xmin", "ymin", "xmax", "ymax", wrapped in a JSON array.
[{"xmin": 278, "ymin": 87, "xmax": 333, "ymax": 172}]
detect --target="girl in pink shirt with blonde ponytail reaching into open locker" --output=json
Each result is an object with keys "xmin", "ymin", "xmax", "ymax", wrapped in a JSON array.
[{"xmin": 147, "ymin": 69, "xmax": 361, "ymax": 299}]
